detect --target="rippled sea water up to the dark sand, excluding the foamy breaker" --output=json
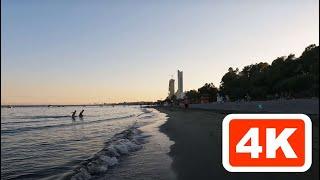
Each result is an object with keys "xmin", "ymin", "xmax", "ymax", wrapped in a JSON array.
[{"xmin": 1, "ymin": 106, "xmax": 174, "ymax": 179}]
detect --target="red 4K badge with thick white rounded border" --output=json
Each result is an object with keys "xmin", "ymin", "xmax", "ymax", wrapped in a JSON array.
[{"xmin": 222, "ymin": 114, "xmax": 312, "ymax": 172}]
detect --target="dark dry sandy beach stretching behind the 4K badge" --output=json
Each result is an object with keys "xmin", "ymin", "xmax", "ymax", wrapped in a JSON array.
[{"xmin": 157, "ymin": 107, "xmax": 319, "ymax": 180}]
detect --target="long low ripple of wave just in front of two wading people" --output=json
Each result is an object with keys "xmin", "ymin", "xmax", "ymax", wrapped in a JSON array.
[{"xmin": 1, "ymin": 115, "xmax": 135, "ymax": 135}]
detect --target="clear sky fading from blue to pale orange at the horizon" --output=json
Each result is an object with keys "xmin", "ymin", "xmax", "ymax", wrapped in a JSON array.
[{"xmin": 1, "ymin": 0, "xmax": 319, "ymax": 104}]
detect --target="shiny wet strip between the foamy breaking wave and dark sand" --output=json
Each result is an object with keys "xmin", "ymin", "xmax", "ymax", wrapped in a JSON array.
[{"xmin": 101, "ymin": 109, "xmax": 176, "ymax": 180}]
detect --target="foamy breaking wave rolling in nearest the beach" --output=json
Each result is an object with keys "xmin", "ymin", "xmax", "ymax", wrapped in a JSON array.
[{"xmin": 66, "ymin": 125, "xmax": 147, "ymax": 180}]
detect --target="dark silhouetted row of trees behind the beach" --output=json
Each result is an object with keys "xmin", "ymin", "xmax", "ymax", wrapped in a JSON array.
[{"xmin": 180, "ymin": 44, "xmax": 319, "ymax": 103}]
